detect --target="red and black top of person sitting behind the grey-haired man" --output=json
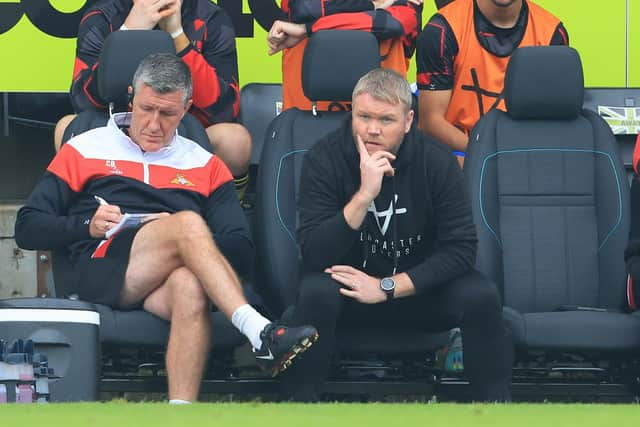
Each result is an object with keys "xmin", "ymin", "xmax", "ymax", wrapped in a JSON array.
[{"xmin": 71, "ymin": 0, "xmax": 240, "ymax": 127}]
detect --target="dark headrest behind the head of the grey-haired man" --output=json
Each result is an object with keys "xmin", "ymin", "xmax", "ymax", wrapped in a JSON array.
[{"xmin": 96, "ymin": 30, "xmax": 176, "ymax": 110}]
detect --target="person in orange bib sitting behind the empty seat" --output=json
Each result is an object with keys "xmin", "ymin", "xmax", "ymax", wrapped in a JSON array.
[{"xmin": 416, "ymin": 0, "xmax": 569, "ymax": 163}]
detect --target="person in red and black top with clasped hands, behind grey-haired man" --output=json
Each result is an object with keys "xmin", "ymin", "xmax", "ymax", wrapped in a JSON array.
[{"xmin": 55, "ymin": 0, "xmax": 251, "ymax": 197}]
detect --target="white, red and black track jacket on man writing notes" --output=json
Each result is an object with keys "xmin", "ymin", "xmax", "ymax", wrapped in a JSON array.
[{"xmin": 15, "ymin": 113, "xmax": 254, "ymax": 272}]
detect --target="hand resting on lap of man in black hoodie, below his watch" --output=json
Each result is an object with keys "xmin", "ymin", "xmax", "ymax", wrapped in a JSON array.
[{"xmin": 324, "ymin": 265, "xmax": 387, "ymax": 304}]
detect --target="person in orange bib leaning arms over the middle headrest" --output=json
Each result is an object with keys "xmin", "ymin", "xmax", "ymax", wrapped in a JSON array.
[{"xmin": 268, "ymin": 0, "xmax": 422, "ymax": 110}]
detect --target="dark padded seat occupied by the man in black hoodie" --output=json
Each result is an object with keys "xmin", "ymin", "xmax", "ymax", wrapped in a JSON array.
[{"xmin": 256, "ymin": 31, "xmax": 447, "ymax": 353}]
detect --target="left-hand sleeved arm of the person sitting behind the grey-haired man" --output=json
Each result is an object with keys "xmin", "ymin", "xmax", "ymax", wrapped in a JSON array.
[{"xmin": 71, "ymin": 10, "xmax": 112, "ymax": 113}]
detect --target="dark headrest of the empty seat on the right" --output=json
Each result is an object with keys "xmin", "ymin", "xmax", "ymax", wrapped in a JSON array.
[{"xmin": 504, "ymin": 46, "xmax": 584, "ymax": 119}]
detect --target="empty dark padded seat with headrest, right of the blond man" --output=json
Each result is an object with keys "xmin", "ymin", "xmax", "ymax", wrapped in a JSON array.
[{"xmin": 464, "ymin": 47, "xmax": 640, "ymax": 353}]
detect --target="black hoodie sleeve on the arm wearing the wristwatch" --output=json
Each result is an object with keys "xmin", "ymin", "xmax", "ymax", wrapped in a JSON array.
[{"xmin": 406, "ymin": 147, "xmax": 477, "ymax": 293}]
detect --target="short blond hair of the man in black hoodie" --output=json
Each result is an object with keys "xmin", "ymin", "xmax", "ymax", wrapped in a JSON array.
[{"xmin": 351, "ymin": 68, "xmax": 412, "ymax": 112}]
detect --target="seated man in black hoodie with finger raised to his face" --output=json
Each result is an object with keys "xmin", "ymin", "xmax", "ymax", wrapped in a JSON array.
[{"xmin": 283, "ymin": 69, "xmax": 513, "ymax": 401}]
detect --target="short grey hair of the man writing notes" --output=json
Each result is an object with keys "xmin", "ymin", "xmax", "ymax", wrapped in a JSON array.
[{"xmin": 132, "ymin": 53, "xmax": 193, "ymax": 104}]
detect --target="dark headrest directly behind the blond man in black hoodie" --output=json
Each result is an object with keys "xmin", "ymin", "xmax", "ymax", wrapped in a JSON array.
[{"xmin": 302, "ymin": 30, "xmax": 380, "ymax": 101}]
